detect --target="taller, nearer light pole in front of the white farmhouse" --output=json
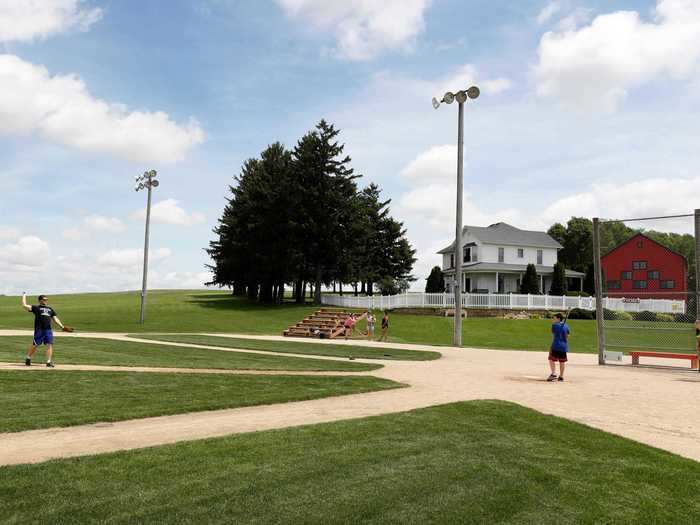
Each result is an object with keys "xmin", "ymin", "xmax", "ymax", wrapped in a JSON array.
[{"xmin": 433, "ymin": 86, "xmax": 480, "ymax": 346}]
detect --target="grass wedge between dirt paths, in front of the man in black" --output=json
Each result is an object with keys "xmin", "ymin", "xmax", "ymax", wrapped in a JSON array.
[{"xmin": 0, "ymin": 371, "xmax": 401, "ymax": 432}]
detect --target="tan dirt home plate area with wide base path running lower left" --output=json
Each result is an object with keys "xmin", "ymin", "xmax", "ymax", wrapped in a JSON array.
[{"xmin": 0, "ymin": 334, "xmax": 700, "ymax": 465}]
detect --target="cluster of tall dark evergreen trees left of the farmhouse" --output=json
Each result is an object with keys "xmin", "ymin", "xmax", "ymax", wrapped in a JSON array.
[{"xmin": 206, "ymin": 120, "xmax": 416, "ymax": 303}]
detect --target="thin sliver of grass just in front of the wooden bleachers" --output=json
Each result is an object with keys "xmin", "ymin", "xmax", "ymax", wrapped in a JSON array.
[{"xmin": 129, "ymin": 334, "xmax": 440, "ymax": 361}]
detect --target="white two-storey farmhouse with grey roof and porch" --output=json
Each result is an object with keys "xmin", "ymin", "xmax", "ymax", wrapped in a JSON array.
[{"xmin": 438, "ymin": 222, "xmax": 584, "ymax": 293}]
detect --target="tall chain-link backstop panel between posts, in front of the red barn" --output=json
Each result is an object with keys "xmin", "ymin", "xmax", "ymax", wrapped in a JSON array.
[{"xmin": 593, "ymin": 210, "xmax": 700, "ymax": 368}]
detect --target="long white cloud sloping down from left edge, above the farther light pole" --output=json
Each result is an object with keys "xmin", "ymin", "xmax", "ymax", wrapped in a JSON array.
[{"xmin": 0, "ymin": 54, "xmax": 204, "ymax": 163}]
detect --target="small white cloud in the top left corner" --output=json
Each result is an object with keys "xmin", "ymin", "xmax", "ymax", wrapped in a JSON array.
[{"xmin": 0, "ymin": 0, "xmax": 102, "ymax": 42}]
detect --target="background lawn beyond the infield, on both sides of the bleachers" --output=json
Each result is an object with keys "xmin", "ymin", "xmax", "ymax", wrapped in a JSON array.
[{"xmin": 0, "ymin": 290, "xmax": 694, "ymax": 353}]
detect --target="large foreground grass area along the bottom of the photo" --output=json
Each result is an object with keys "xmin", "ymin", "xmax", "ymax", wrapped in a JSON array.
[{"xmin": 0, "ymin": 401, "xmax": 700, "ymax": 525}]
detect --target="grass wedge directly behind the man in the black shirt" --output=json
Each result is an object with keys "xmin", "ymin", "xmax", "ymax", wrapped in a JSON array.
[{"xmin": 0, "ymin": 337, "xmax": 381, "ymax": 372}]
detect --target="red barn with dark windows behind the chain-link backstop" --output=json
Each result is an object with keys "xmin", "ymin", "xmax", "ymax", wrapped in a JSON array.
[{"xmin": 601, "ymin": 233, "xmax": 688, "ymax": 300}]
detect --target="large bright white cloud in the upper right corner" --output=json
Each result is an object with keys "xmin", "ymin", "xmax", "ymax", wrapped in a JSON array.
[{"xmin": 535, "ymin": 0, "xmax": 700, "ymax": 111}]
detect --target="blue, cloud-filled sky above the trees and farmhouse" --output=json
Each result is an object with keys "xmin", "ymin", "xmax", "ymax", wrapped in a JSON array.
[{"xmin": 0, "ymin": 0, "xmax": 700, "ymax": 295}]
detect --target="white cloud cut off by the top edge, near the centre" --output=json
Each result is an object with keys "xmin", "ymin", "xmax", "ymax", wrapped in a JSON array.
[{"xmin": 277, "ymin": 0, "xmax": 431, "ymax": 60}]
